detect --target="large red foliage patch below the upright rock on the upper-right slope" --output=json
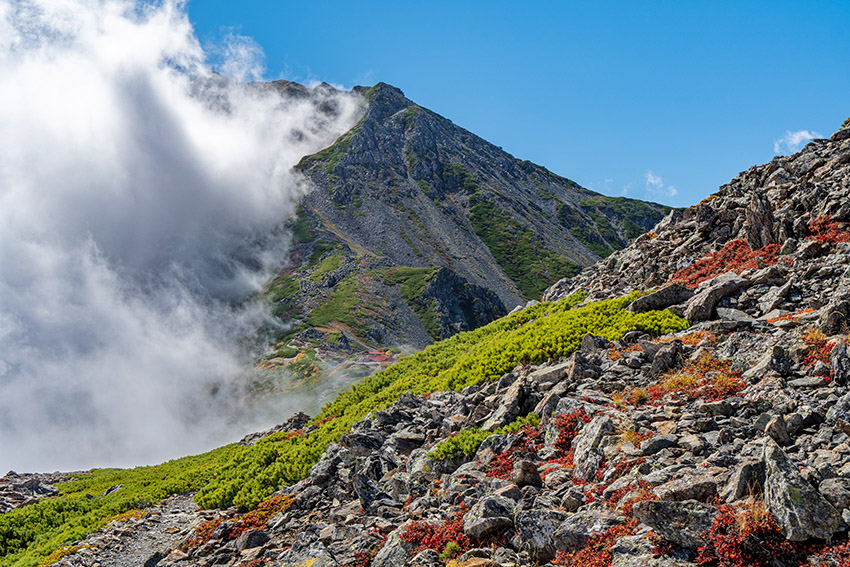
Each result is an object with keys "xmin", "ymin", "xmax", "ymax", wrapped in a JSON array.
[{"xmin": 670, "ymin": 240, "xmax": 780, "ymax": 288}]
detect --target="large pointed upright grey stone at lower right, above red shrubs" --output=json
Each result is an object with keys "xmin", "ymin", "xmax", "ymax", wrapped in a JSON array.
[{"xmin": 762, "ymin": 437, "xmax": 845, "ymax": 541}]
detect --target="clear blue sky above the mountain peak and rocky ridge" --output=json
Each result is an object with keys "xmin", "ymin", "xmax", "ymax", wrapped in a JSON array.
[{"xmin": 188, "ymin": 0, "xmax": 850, "ymax": 206}]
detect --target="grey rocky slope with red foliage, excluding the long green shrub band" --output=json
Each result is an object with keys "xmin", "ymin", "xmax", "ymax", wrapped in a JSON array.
[{"xmin": 23, "ymin": 120, "xmax": 850, "ymax": 567}]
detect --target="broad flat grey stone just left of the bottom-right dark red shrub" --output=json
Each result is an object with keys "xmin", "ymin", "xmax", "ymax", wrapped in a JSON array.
[{"xmin": 633, "ymin": 500, "xmax": 718, "ymax": 549}]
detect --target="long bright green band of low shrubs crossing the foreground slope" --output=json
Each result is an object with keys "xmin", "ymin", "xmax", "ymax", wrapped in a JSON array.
[{"xmin": 0, "ymin": 290, "xmax": 688, "ymax": 567}]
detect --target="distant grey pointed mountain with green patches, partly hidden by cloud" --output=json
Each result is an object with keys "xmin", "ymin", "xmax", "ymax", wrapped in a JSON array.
[{"xmin": 252, "ymin": 81, "xmax": 671, "ymax": 390}]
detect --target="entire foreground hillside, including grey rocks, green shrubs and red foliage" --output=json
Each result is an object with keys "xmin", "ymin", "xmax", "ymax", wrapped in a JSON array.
[{"xmin": 0, "ymin": 120, "xmax": 850, "ymax": 567}]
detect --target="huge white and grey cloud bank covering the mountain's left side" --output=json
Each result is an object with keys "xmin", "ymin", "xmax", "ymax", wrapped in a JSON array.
[{"xmin": 0, "ymin": 0, "xmax": 359, "ymax": 474}]
